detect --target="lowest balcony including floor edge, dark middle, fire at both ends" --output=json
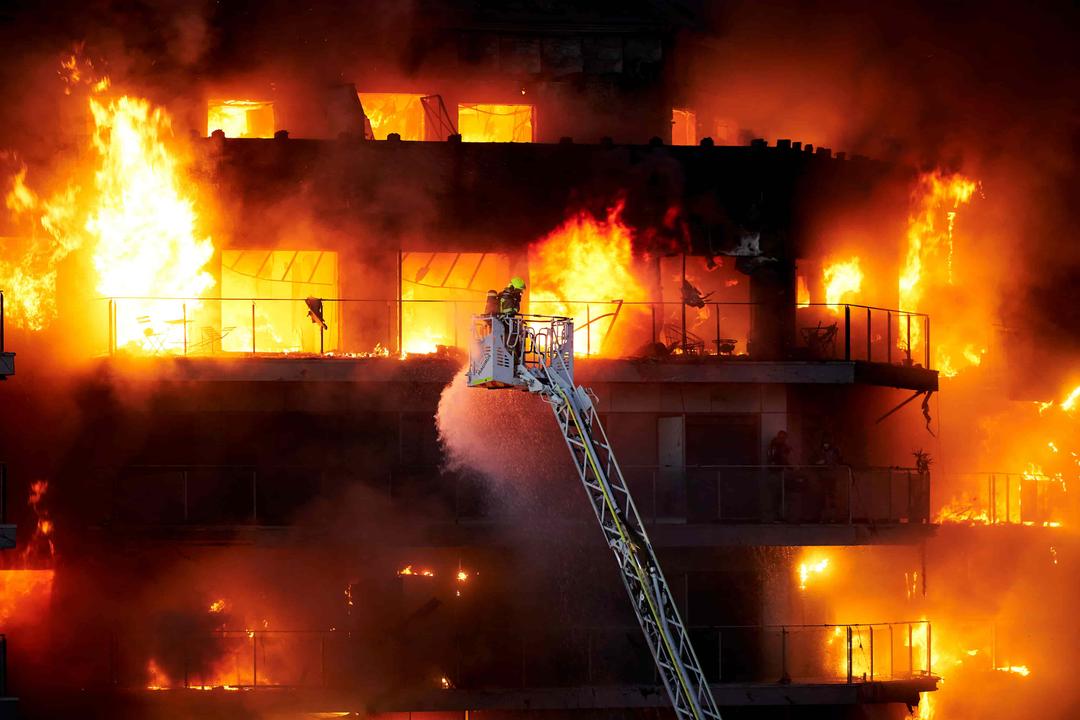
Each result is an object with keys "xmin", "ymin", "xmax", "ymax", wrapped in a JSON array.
[{"xmin": 95, "ymin": 621, "xmax": 937, "ymax": 711}]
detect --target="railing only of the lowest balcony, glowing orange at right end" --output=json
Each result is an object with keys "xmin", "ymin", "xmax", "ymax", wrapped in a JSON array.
[{"xmin": 109, "ymin": 621, "xmax": 932, "ymax": 690}]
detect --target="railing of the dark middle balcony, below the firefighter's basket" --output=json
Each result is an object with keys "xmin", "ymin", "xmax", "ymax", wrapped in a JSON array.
[{"xmin": 103, "ymin": 465, "xmax": 930, "ymax": 527}]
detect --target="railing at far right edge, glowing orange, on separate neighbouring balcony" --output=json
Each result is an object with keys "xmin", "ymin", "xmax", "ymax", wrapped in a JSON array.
[{"xmin": 935, "ymin": 473, "xmax": 1078, "ymax": 527}]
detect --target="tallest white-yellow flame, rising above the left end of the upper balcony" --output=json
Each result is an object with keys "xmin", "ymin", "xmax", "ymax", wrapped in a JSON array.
[{"xmin": 86, "ymin": 96, "xmax": 214, "ymax": 351}]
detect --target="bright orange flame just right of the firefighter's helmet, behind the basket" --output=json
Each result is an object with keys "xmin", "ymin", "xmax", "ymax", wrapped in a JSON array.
[{"xmin": 529, "ymin": 202, "xmax": 649, "ymax": 354}]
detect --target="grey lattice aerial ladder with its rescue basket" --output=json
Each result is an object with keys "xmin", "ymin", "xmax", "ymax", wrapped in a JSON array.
[{"xmin": 468, "ymin": 314, "xmax": 720, "ymax": 720}]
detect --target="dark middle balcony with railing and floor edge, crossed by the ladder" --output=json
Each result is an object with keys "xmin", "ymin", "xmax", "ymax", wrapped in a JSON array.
[{"xmin": 102, "ymin": 465, "xmax": 934, "ymax": 547}]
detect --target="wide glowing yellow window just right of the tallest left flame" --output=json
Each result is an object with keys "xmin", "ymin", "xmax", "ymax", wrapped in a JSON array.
[{"xmin": 219, "ymin": 250, "xmax": 340, "ymax": 353}]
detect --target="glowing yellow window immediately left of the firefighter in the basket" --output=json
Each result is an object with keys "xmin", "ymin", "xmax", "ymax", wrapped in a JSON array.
[{"xmin": 402, "ymin": 253, "xmax": 510, "ymax": 353}]
